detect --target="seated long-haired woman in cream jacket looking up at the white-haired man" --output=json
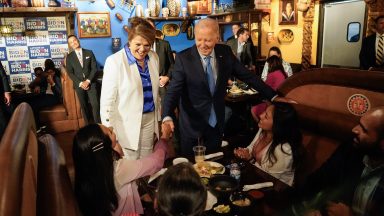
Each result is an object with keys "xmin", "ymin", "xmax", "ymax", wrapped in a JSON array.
[{"xmin": 234, "ymin": 102, "xmax": 303, "ymax": 186}]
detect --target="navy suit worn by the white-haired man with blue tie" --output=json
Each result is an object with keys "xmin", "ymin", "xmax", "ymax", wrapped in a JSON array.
[{"xmin": 162, "ymin": 44, "xmax": 276, "ymax": 155}]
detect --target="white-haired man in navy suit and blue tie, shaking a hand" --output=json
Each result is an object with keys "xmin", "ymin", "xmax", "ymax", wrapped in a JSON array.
[{"xmin": 162, "ymin": 18, "xmax": 284, "ymax": 156}]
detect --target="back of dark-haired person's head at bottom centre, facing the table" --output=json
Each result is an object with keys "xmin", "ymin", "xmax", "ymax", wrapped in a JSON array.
[{"xmin": 157, "ymin": 163, "xmax": 207, "ymax": 216}]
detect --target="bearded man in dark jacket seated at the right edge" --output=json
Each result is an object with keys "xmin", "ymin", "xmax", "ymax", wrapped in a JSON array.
[{"xmin": 299, "ymin": 107, "xmax": 384, "ymax": 216}]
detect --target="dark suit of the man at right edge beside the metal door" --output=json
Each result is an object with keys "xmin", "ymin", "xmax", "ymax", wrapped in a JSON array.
[{"xmin": 359, "ymin": 33, "xmax": 384, "ymax": 70}]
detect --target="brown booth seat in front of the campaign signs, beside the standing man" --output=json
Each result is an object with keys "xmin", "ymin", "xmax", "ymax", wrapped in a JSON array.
[{"xmin": 39, "ymin": 67, "xmax": 85, "ymax": 133}]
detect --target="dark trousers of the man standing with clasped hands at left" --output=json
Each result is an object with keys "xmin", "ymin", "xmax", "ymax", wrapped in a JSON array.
[{"xmin": 75, "ymin": 83, "xmax": 101, "ymax": 124}]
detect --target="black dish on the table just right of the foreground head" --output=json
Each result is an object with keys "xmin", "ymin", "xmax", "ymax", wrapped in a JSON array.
[{"xmin": 208, "ymin": 175, "xmax": 239, "ymax": 202}]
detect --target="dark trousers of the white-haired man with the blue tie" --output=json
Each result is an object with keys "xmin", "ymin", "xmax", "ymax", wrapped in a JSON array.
[{"xmin": 180, "ymin": 125, "xmax": 223, "ymax": 157}]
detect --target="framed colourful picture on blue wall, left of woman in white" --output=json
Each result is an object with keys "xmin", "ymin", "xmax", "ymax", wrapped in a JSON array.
[{"xmin": 77, "ymin": 12, "xmax": 111, "ymax": 38}]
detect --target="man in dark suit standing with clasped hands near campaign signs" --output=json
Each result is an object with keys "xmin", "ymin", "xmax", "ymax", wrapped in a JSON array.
[{"xmin": 66, "ymin": 35, "xmax": 101, "ymax": 124}]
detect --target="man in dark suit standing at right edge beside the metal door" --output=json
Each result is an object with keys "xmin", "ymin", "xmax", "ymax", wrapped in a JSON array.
[{"xmin": 359, "ymin": 16, "xmax": 384, "ymax": 70}]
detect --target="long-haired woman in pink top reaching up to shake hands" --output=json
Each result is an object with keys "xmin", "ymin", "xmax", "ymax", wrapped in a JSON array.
[{"xmin": 72, "ymin": 124, "xmax": 171, "ymax": 216}]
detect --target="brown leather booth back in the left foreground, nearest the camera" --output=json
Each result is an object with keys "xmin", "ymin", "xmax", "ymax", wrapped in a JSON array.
[{"xmin": 0, "ymin": 103, "xmax": 80, "ymax": 216}]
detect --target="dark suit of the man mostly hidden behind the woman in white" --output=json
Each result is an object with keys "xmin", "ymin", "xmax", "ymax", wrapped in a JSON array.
[{"xmin": 155, "ymin": 39, "xmax": 175, "ymax": 98}]
